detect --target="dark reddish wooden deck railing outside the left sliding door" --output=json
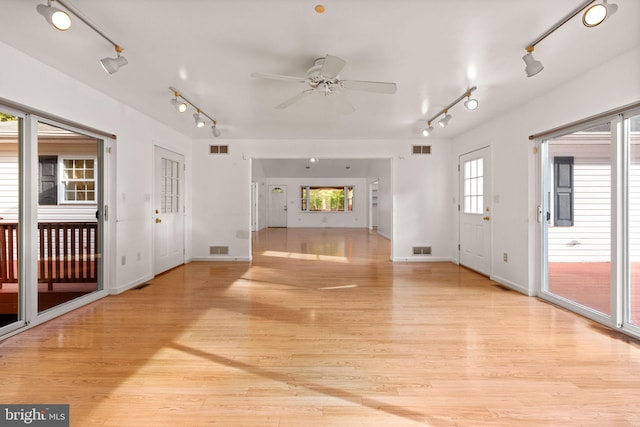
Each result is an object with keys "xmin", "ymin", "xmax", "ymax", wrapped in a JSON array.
[{"xmin": 0, "ymin": 222, "xmax": 98, "ymax": 290}]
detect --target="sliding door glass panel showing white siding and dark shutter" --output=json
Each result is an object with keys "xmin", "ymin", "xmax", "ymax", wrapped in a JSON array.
[{"xmin": 546, "ymin": 123, "xmax": 612, "ymax": 315}]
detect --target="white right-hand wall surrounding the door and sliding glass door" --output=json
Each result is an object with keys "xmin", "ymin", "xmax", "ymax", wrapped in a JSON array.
[{"xmin": 450, "ymin": 48, "xmax": 640, "ymax": 294}]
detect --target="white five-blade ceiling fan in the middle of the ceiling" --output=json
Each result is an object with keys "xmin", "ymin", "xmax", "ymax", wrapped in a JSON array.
[{"xmin": 251, "ymin": 55, "xmax": 396, "ymax": 114}]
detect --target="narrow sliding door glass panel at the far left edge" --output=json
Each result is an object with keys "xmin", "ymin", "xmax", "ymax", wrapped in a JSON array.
[{"xmin": 0, "ymin": 110, "xmax": 23, "ymax": 329}]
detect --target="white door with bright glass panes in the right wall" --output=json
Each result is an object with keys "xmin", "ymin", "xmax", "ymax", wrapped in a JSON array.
[{"xmin": 459, "ymin": 147, "xmax": 492, "ymax": 276}]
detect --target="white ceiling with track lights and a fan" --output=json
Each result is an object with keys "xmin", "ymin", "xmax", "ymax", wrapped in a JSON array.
[{"xmin": 0, "ymin": 0, "xmax": 640, "ymax": 140}]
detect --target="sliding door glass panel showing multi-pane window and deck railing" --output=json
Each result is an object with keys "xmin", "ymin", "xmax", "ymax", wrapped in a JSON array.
[{"xmin": 37, "ymin": 122, "xmax": 101, "ymax": 312}]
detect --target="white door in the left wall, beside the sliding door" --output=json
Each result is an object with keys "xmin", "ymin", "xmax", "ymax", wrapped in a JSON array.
[{"xmin": 153, "ymin": 146, "xmax": 184, "ymax": 274}]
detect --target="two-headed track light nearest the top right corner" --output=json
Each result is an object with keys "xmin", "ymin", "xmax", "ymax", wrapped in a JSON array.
[{"xmin": 522, "ymin": 0, "xmax": 618, "ymax": 77}]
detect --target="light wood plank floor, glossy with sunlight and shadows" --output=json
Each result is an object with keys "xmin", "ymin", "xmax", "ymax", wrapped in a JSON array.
[{"xmin": 0, "ymin": 229, "xmax": 640, "ymax": 427}]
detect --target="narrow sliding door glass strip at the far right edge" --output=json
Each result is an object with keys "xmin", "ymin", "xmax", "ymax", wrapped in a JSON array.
[{"xmin": 626, "ymin": 116, "xmax": 640, "ymax": 326}]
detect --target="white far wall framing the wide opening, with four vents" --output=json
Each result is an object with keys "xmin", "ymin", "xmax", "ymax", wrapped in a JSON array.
[{"xmin": 193, "ymin": 140, "xmax": 453, "ymax": 261}]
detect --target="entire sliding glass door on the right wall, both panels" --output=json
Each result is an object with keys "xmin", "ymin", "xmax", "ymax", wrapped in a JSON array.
[{"xmin": 539, "ymin": 106, "xmax": 640, "ymax": 336}]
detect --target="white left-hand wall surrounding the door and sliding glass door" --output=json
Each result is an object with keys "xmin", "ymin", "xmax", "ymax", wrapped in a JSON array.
[{"xmin": 0, "ymin": 43, "xmax": 191, "ymax": 292}]
